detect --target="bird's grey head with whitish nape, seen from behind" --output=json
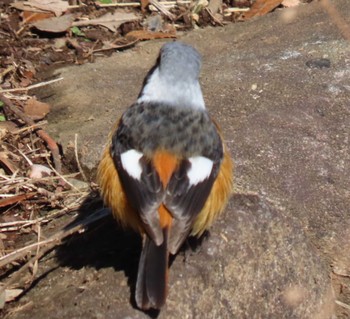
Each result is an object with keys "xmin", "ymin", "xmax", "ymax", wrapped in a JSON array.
[{"xmin": 138, "ymin": 42, "xmax": 205, "ymax": 109}]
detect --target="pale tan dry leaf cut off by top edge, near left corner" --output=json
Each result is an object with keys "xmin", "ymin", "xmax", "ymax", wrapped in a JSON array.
[{"xmin": 12, "ymin": 0, "xmax": 69, "ymax": 17}]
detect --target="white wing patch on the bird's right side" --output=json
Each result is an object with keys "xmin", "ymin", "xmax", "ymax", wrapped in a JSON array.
[{"xmin": 187, "ymin": 156, "xmax": 213, "ymax": 186}]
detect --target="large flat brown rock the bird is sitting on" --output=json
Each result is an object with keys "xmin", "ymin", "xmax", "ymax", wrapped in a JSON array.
[{"xmin": 0, "ymin": 0, "xmax": 350, "ymax": 318}]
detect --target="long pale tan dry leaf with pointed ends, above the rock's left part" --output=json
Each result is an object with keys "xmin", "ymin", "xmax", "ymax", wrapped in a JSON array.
[{"xmin": 73, "ymin": 11, "xmax": 139, "ymax": 32}]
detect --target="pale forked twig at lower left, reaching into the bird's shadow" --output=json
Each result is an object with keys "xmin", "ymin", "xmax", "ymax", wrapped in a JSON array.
[{"xmin": 0, "ymin": 209, "xmax": 109, "ymax": 289}]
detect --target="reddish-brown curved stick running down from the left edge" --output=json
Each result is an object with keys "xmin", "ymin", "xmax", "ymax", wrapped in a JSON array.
[{"xmin": 0, "ymin": 94, "xmax": 62, "ymax": 173}]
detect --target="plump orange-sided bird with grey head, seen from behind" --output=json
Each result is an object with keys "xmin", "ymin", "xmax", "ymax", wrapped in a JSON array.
[{"xmin": 97, "ymin": 41, "xmax": 233, "ymax": 310}]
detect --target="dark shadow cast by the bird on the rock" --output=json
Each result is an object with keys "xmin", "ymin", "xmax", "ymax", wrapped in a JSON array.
[{"xmin": 56, "ymin": 192, "xmax": 206, "ymax": 318}]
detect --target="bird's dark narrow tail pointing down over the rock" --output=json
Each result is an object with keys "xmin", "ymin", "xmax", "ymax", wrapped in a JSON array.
[{"xmin": 135, "ymin": 227, "xmax": 169, "ymax": 310}]
